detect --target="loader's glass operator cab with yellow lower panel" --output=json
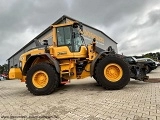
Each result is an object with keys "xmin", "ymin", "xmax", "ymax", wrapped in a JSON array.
[{"xmin": 56, "ymin": 23, "xmax": 87, "ymax": 58}]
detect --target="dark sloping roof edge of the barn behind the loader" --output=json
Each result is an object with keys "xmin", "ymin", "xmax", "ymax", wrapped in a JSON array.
[{"xmin": 7, "ymin": 15, "xmax": 117, "ymax": 60}]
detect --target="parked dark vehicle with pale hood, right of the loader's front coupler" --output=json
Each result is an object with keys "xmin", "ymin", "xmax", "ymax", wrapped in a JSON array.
[{"xmin": 137, "ymin": 58, "xmax": 158, "ymax": 73}]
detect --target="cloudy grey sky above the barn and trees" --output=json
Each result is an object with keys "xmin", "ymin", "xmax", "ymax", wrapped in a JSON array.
[{"xmin": 0, "ymin": 0, "xmax": 160, "ymax": 65}]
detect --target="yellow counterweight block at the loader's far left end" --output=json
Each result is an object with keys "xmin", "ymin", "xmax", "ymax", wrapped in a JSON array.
[{"xmin": 9, "ymin": 68, "xmax": 22, "ymax": 79}]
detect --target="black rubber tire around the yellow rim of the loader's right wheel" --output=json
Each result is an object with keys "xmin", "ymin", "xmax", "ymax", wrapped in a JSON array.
[{"xmin": 95, "ymin": 55, "xmax": 130, "ymax": 90}]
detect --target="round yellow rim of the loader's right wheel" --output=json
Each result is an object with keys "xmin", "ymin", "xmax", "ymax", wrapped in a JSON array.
[{"xmin": 104, "ymin": 63, "xmax": 123, "ymax": 82}]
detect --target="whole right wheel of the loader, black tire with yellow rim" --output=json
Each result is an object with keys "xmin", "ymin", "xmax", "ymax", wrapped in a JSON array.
[{"xmin": 95, "ymin": 56, "xmax": 130, "ymax": 90}]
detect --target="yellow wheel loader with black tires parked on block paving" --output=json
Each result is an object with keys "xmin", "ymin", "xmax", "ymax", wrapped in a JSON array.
[{"xmin": 9, "ymin": 22, "xmax": 148, "ymax": 95}]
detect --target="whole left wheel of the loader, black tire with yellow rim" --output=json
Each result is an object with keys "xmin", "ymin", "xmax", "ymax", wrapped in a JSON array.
[{"xmin": 26, "ymin": 63, "xmax": 59, "ymax": 95}]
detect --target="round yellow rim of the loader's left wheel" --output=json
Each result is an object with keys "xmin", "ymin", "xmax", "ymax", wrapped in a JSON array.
[{"xmin": 32, "ymin": 71, "xmax": 48, "ymax": 88}]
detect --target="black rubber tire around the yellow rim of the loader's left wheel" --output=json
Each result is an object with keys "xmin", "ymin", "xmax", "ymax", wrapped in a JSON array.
[{"xmin": 26, "ymin": 63, "xmax": 59, "ymax": 95}]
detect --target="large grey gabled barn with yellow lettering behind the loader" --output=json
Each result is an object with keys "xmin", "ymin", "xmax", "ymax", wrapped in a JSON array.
[{"xmin": 7, "ymin": 15, "xmax": 118, "ymax": 69}]
